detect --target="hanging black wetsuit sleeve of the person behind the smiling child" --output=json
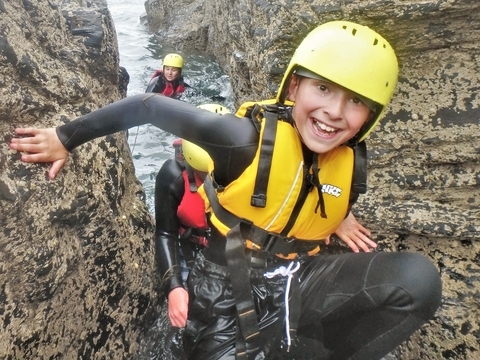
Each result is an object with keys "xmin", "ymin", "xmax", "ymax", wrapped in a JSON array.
[{"xmin": 155, "ymin": 159, "xmax": 185, "ymax": 295}]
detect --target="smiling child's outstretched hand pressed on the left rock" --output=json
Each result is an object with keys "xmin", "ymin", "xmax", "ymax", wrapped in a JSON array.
[{"xmin": 9, "ymin": 128, "xmax": 69, "ymax": 179}]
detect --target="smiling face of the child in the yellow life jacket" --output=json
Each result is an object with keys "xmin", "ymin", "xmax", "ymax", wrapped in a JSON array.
[{"xmin": 288, "ymin": 75, "xmax": 372, "ymax": 154}]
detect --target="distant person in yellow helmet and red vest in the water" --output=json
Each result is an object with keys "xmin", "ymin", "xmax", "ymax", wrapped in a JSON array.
[{"xmin": 145, "ymin": 54, "xmax": 190, "ymax": 99}]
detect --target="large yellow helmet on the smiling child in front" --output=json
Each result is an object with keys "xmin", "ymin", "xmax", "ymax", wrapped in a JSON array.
[{"xmin": 276, "ymin": 21, "xmax": 398, "ymax": 141}]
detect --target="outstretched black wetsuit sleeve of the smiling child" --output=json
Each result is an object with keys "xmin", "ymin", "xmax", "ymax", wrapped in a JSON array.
[{"xmin": 57, "ymin": 94, "xmax": 259, "ymax": 185}]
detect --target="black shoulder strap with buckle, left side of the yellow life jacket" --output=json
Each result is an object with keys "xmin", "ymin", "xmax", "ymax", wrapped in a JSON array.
[{"xmin": 250, "ymin": 111, "xmax": 278, "ymax": 208}]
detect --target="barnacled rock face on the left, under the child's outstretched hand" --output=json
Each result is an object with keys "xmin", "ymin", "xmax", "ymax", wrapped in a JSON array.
[{"xmin": 0, "ymin": 0, "xmax": 157, "ymax": 359}]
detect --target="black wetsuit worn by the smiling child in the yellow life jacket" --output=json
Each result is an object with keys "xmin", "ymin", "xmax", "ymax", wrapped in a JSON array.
[{"xmin": 57, "ymin": 95, "xmax": 441, "ymax": 360}]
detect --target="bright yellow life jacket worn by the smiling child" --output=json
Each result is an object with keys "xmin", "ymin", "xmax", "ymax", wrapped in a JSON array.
[{"xmin": 199, "ymin": 100, "xmax": 364, "ymax": 255}]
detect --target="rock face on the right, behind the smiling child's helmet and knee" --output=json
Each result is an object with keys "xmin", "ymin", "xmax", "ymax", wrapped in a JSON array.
[{"xmin": 145, "ymin": 0, "xmax": 480, "ymax": 360}]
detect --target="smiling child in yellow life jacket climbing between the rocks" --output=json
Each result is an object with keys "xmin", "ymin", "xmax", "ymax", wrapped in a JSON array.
[{"xmin": 10, "ymin": 21, "xmax": 442, "ymax": 360}]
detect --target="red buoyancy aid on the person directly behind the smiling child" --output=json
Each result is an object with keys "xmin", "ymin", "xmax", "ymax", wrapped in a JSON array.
[{"xmin": 177, "ymin": 170, "xmax": 208, "ymax": 245}]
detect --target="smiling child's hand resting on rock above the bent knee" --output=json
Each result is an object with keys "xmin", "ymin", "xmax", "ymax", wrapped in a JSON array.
[{"xmin": 325, "ymin": 213, "xmax": 377, "ymax": 252}]
